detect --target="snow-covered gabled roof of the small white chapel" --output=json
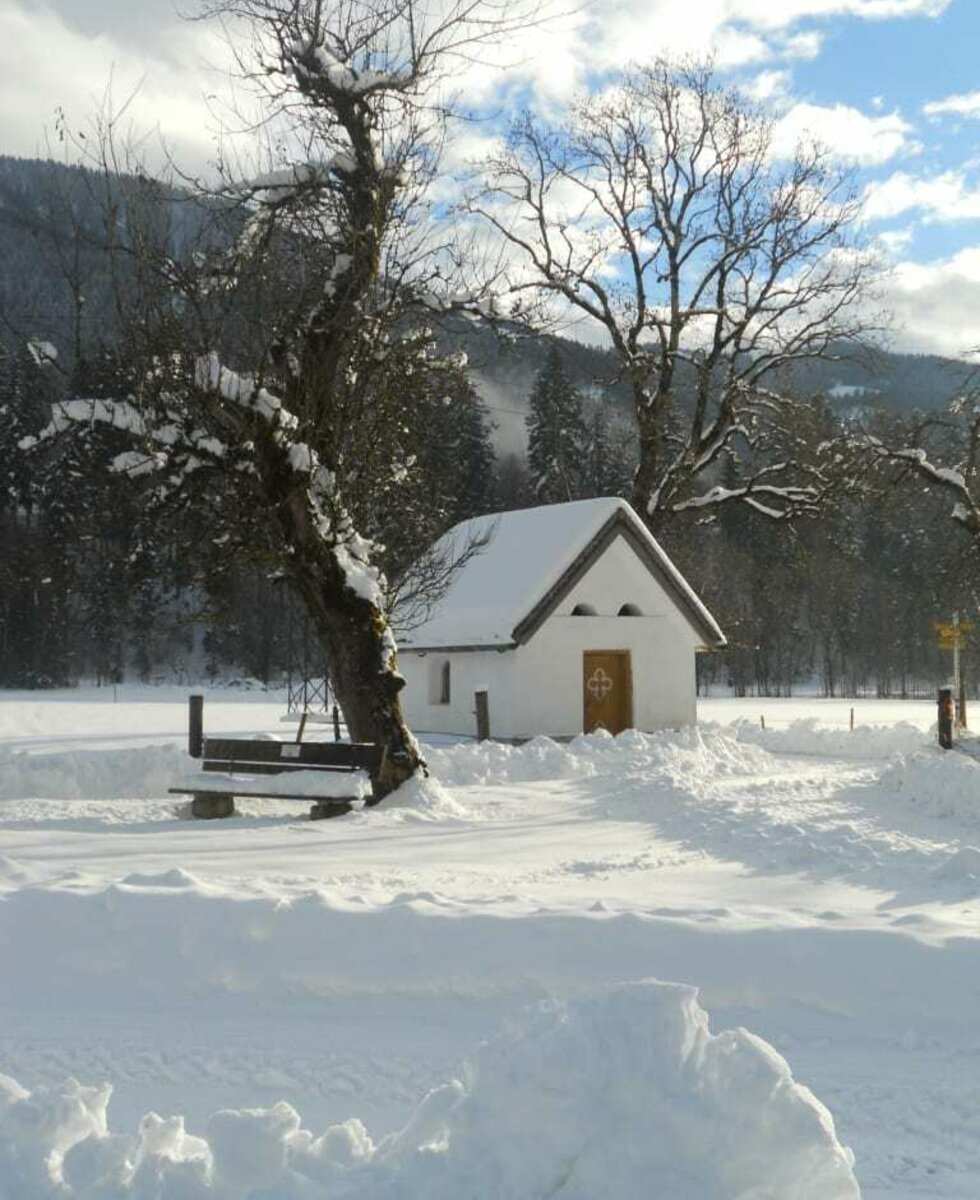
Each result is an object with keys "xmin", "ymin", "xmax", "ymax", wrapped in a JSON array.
[{"xmin": 398, "ymin": 498, "xmax": 725, "ymax": 650}]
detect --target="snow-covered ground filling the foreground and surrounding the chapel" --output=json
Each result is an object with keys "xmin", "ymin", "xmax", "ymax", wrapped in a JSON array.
[{"xmin": 0, "ymin": 688, "xmax": 980, "ymax": 1200}]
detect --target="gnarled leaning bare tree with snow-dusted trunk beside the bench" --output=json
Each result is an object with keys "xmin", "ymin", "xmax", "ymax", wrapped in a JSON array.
[{"xmin": 24, "ymin": 0, "xmax": 536, "ymax": 797}]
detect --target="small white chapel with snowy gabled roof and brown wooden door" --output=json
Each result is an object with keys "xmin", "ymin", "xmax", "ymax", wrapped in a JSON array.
[{"xmin": 398, "ymin": 499, "xmax": 725, "ymax": 739}]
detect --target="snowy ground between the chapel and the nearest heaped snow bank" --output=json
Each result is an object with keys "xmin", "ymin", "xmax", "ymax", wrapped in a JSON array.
[{"xmin": 0, "ymin": 691, "xmax": 980, "ymax": 1200}]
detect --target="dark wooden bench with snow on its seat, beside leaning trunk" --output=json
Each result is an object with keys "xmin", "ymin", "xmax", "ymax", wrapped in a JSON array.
[{"xmin": 169, "ymin": 738, "xmax": 383, "ymax": 821}]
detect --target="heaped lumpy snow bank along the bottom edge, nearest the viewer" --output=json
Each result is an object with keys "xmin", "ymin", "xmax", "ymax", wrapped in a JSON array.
[{"xmin": 0, "ymin": 980, "xmax": 860, "ymax": 1200}]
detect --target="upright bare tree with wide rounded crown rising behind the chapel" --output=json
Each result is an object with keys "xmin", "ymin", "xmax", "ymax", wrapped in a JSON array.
[{"xmin": 467, "ymin": 62, "xmax": 878, "ymax": 524}]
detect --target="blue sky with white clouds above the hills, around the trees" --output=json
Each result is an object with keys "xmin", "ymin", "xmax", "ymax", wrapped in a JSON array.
[{"xmin": 0, "ymin": 0, "xmax": 980, "ymax": 354}]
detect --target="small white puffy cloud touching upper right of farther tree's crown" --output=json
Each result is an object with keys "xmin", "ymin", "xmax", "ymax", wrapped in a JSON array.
[{"xmin": 774, "ymin": 103, "xmax": 919, "ymax": 166}]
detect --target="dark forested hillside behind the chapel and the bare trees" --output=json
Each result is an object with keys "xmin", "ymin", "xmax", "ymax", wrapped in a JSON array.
[{"xmin": 0, "ymin": 158, "xmax": 980, "ymax": 694}]
